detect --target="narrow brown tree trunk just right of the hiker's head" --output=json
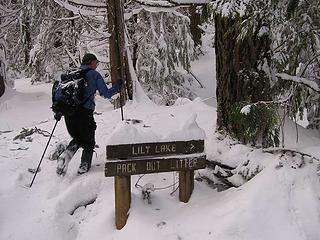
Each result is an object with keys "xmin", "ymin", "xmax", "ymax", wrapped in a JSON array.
[{"xmin": 107, "ymin": 0, "xmax": 131, "ymax": 103}]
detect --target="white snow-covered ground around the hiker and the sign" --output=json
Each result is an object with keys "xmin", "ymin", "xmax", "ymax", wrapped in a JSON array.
[{"xmin": 0, "ymin": 66, "xmax": 320, "ymax": 240}]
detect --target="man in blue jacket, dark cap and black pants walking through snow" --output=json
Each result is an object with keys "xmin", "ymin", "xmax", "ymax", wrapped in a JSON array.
[{"xmin": 57, "ymin": 53, "xmax": 122, "ymax": 176}]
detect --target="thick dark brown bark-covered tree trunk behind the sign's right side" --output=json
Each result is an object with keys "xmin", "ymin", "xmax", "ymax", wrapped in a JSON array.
[{"xmin": 215, "ymin": 1, "xmax": 273, "ymax": 146}]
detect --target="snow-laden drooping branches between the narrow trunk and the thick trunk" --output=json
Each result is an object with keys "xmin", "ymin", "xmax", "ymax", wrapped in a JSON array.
[{"xmin": 128, "ymin": 7, "xmax": 194, "ymax": 105}]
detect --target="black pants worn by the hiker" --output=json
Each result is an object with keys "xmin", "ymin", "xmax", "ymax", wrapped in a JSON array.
[{"xmin": 64, "ymin": 108, "xmax": 97, "ymax": 168}]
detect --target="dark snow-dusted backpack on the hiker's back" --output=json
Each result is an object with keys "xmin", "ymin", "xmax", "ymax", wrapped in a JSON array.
[{"xmin": 51, "ymin": 69, "xmax": 91, "ymax": 116}]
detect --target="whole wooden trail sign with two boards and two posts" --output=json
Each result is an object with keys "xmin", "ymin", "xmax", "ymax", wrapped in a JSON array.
[{"xmin": 105, "ymin": 140, "xmax": 206, "ymax": 229}]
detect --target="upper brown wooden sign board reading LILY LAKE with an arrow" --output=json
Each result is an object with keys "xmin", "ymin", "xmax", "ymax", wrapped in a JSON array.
[{"xmin": 107, "ymin": 140, "xmax": 204, "ymax": 160}]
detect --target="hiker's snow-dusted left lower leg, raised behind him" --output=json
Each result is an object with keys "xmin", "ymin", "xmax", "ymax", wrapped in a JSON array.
[{"xmin": 57, "ymin": 140, "xmax": 79, "ymax": 176}]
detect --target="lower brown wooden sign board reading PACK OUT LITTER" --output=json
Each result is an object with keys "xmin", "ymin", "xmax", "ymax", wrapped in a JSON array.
[{"xmin": 105, "ymin": 155, "xmax": 206, "ymax": 177}]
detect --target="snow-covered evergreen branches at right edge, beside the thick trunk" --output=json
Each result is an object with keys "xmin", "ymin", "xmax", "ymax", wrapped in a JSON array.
[{"xmin": 272, "ymin": 0, "xmax": 320, "ymax": 129}]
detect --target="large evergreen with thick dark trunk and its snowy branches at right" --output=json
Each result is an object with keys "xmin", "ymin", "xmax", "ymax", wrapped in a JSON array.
[{"xmin": 210, "ymin": 0, "xmax": 319, "ymax": 146}]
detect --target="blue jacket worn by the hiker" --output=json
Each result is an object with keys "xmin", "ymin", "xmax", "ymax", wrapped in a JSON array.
[{"xmin": 80, "ymin": 65, "xmax": 120, "ymax": 110}]
